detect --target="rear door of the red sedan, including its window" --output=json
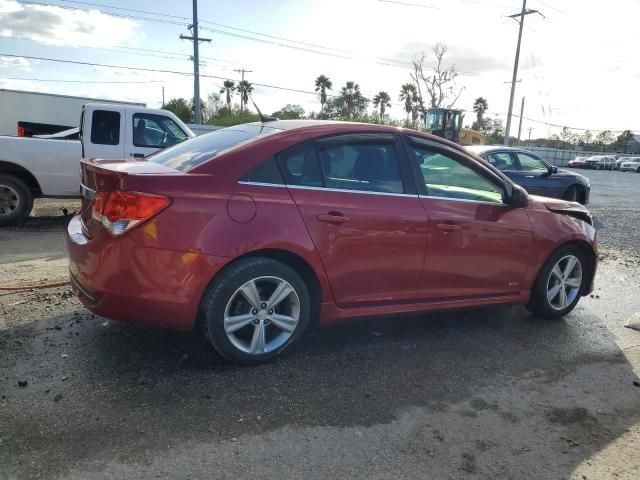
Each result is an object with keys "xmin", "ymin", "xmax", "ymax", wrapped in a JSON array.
[{"xmin": 278, "ymin": 134, "xmax": 427, "ymax": 307}]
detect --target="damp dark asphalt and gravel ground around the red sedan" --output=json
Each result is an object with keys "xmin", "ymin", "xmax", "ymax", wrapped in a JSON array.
[{"xmin": 0, "ymin": 171, "xmax": 640, "ymax": 480}]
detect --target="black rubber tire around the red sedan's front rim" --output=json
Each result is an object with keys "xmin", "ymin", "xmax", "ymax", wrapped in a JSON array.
[{"xmin": 526, "ymin": 245, "xmax": 590, "ymax": 318}]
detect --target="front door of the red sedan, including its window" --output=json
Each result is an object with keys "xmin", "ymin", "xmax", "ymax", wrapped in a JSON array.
[{"xmin": 408, "ymin": 138, "xmax": 533, "ymax": 301}]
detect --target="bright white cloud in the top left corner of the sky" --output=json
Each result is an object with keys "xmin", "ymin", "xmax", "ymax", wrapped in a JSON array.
[{"xmin": 0, "ymin": 0, "xmax": 136, "ymax": 47}]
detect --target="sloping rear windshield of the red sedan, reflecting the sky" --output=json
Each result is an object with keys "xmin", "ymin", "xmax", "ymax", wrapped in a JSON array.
[{"xmin": 148, "ymin": 124, "xmax": 280, "ymax": 172}]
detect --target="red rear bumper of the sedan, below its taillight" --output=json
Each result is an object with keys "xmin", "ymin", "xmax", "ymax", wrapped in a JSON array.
[{"xmin": 67, "ymin": 216, "xmax": 228, "ymax": 330}]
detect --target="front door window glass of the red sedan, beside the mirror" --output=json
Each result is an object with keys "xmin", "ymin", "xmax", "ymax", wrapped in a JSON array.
[{"xmin": 411, "ymin": 146, "xmax": 502, "ymax": 203}]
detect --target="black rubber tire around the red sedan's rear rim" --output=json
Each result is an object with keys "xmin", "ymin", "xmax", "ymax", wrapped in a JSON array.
[{"xmin": 201, "ymin": 257, "xmax": 311, "ymax": 365}]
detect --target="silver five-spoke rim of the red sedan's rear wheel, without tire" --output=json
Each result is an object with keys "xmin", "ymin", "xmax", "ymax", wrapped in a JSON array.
[{"xmin": 224, "ymin": 276, "xmax": 300, "ymax": 355}]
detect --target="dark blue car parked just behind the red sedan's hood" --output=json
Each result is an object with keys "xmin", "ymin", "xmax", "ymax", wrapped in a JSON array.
[{"xmin": 465, "ymin": 145, "xmax": 591, "ymax": 204}]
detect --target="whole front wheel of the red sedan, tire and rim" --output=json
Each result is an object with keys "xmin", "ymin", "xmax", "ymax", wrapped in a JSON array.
[{"xmin": 527, "ymin": 245, "xmax": 587, "ymax": 318}]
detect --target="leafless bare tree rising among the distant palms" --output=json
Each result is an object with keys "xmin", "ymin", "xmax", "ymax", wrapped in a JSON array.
[{"xmin": 411, "ymin": 43, "xmax": 464, "ymax": 108}]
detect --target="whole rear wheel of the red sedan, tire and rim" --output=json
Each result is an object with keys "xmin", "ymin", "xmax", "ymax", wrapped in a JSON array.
[{"xmin": 203, "ymin": 258, "xmax": 310, "ymax": 364}]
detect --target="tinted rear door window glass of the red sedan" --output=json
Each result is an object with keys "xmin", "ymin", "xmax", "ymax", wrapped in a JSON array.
[{"xmin": 319, "ymin": 142, "xmax": 404, "ymax": 193}]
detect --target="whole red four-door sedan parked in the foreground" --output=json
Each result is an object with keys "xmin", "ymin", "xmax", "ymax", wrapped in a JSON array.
[{"xmin": 67, "ymin": 121, "xmax": 597, "ymax": 363}]
